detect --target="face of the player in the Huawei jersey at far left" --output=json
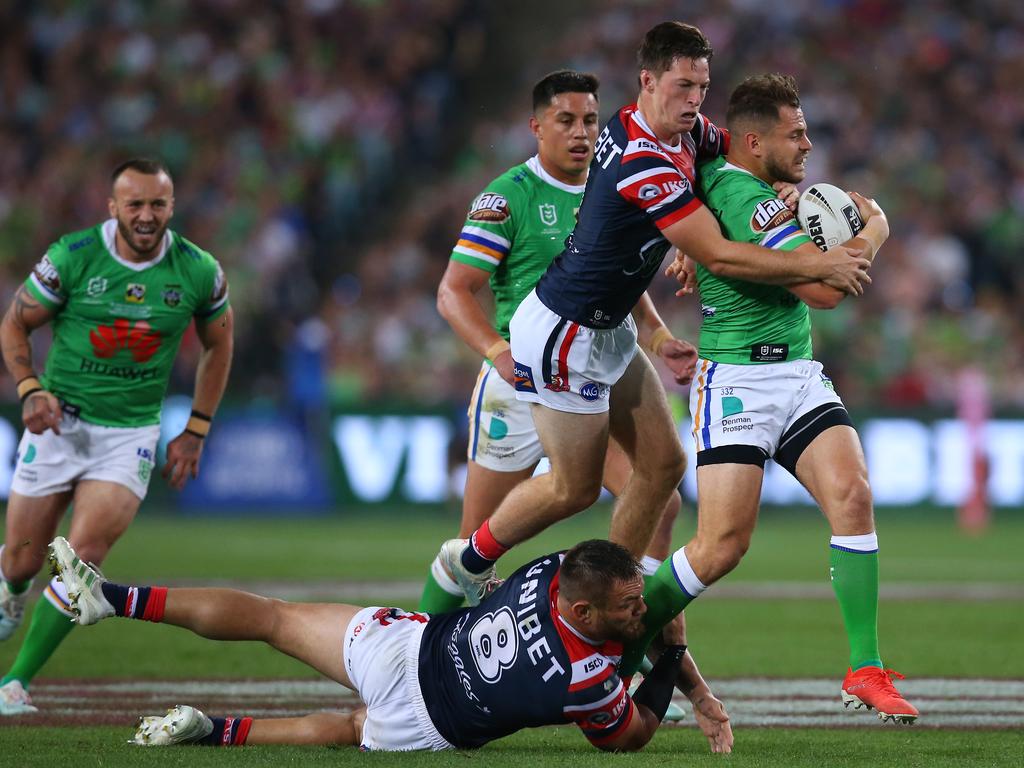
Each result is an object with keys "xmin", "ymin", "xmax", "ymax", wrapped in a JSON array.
[{"xmin": 108, "ymin": 168, "xmax": 174, "ymax": 257}]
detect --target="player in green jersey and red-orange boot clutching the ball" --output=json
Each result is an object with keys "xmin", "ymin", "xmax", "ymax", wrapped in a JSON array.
[{"xmin": 673, "ymin": 75, "xmax": 918, "ymax": 723}]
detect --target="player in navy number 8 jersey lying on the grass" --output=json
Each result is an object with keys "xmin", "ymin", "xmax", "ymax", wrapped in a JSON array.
[{"xmin": 50, "ymin": 537, "xmax": 732, "ymax": 752}]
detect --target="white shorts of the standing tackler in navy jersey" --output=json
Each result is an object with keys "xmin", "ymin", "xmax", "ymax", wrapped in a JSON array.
[{"xmin": 509, "ymin": 291, "xmax": 638, "ymax": 414}]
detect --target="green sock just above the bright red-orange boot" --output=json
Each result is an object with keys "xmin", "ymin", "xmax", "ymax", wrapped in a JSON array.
[{"xmin": 829, "ymin": 545, "xmax": 882, "ymax": 670}]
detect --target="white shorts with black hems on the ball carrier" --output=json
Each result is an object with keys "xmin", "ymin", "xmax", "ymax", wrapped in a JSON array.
[{"xmin": 690, "ymin": 359, "xmax": 849, "ymax": 471}]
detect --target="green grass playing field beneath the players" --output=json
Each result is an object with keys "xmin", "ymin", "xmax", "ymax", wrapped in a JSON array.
[{"xmin": 0, "ymin": 509, "xmax": 1024, "ymax": 768}]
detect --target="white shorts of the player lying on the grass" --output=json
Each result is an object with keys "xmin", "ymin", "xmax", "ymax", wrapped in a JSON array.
[{"xmin": 344, "ymin": 607, "xmax": 454, "ymax": 752}]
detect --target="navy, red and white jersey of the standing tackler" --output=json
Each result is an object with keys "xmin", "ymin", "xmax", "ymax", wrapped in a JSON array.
[{"xmin": 537, "ymin": 104, "xmax": 729, "ymax": 329}]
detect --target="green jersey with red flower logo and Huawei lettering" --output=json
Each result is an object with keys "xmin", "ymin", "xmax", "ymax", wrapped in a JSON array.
[{"xmin": 25, "ymin": 219, "xmax": 227, "ymax": 427}]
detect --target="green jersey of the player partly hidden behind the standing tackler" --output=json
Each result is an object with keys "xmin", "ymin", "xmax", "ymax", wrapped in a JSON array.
[{"xmin": 452, "ymin": 155, "xmax": 586, "ymax": 339}]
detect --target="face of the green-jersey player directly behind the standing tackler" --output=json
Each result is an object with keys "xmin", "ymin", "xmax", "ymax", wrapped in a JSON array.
[{"xmin": 530, "ymin": 93, "xmax": 598, "ymax": 184}]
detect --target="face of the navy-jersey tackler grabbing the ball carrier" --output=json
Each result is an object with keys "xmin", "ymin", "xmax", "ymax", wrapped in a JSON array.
[{"xmin": 640, "ymin": 58, "xmax": 711, "ymax": 144}]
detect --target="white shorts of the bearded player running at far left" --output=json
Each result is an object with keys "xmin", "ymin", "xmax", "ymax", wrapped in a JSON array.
[{"xmin": 10, "ymin": 412, "xmax": 160, "ymax": 501}]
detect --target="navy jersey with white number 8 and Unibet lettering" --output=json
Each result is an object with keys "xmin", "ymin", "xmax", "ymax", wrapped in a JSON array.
[{"xmin": 419, "ymin": 555, "xmax": 635, "ymax": 748}]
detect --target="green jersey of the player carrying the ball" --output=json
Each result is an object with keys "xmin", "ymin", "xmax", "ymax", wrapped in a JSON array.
[{"xmin": 697, "ymin": 157, "xmax": 811, "ymax": 365}]
